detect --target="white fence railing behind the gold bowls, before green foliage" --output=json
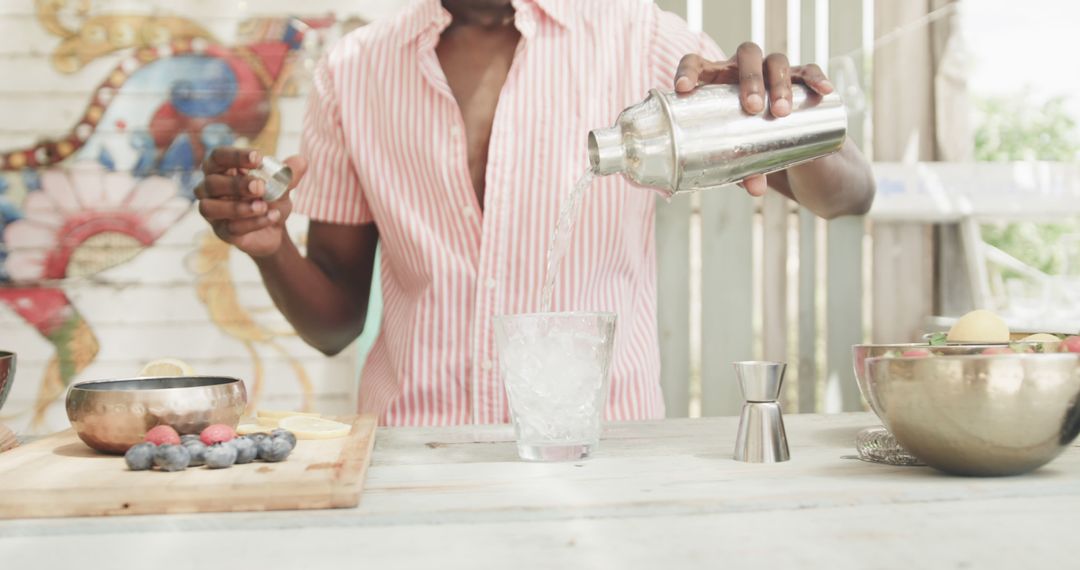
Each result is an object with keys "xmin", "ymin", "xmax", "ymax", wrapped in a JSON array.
[{"xmin": 869, "ymin": 162, "xmax": 1080, "ymax": 333}]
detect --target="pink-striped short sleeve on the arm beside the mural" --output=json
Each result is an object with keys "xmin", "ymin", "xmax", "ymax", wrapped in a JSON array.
[{"xmin": 293, "ymin": 57, "xmax": 375, "ymax": 226}]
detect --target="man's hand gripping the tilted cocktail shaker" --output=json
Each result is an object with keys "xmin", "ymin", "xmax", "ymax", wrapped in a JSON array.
[{"xmin": 675, "ymin": 42, "xmax": 833, "ymax": 196}]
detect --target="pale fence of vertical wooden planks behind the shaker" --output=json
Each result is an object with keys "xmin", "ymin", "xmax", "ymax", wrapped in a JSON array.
[{"xmin": 657, "ymin": 0, "xmax": 866, "ymax": 417}]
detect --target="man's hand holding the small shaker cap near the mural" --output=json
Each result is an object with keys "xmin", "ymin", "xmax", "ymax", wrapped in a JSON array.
[{"xmin": 195, "ymin": 147, "xmax": 308, "ymax": 257}]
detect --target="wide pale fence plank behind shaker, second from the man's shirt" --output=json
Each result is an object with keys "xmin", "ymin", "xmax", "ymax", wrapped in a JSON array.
[{"xmin": 701, "ymin": 0, "xmax": 754, "ymax": 416}]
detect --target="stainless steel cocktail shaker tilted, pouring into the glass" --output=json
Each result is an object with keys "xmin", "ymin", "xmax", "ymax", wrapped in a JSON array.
[{"xmin": 589, "ymin": 84, "xmax": 848, "ymax": 196}]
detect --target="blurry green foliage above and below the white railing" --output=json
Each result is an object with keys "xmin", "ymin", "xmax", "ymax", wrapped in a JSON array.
[{"xmin": 975, "ymin": 94, "xmax": 1080, "ymax": 277}]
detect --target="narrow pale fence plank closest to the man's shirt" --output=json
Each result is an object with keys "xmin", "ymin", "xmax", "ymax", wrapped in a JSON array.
[{"xmin": 656, "ymin": 0, "xmax": 690, "ymax": 418}]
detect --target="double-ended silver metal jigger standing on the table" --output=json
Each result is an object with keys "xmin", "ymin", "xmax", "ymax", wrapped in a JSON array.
[{"xmin": 734, "ymin": 361, "xmax": 791, "ymax": 463}]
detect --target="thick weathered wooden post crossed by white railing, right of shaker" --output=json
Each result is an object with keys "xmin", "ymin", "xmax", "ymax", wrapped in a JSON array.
[{"xmin": 872, "ymin": 0, "xmax": 974, "ymax": 342}]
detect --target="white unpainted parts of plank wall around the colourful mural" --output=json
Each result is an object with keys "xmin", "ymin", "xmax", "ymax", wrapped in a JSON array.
[{"xmin": 0, "ymin": 0, "xmax": 405, "ymax": 432}]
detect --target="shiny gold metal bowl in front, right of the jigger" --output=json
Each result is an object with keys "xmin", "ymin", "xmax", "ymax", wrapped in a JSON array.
[{"xmin": 866, "ymin": 353, "xmax": 1080, "ymax": 476}]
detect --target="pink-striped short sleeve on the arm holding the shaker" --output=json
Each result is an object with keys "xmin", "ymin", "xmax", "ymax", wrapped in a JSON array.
[{"xmin": 650, "ymin": 4, "xmax": 727, "ymax": 90}]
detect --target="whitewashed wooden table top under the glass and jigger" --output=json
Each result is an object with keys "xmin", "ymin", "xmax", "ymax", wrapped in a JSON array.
[{"xmin": 0, "ymin": 413, "xmax": 1080, "ymax": 570}]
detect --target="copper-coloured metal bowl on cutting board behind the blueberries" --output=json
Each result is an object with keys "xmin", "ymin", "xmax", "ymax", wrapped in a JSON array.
[{"xmin": 67, "ymin": 376, "xmax": 247, "ymax": 453}]
